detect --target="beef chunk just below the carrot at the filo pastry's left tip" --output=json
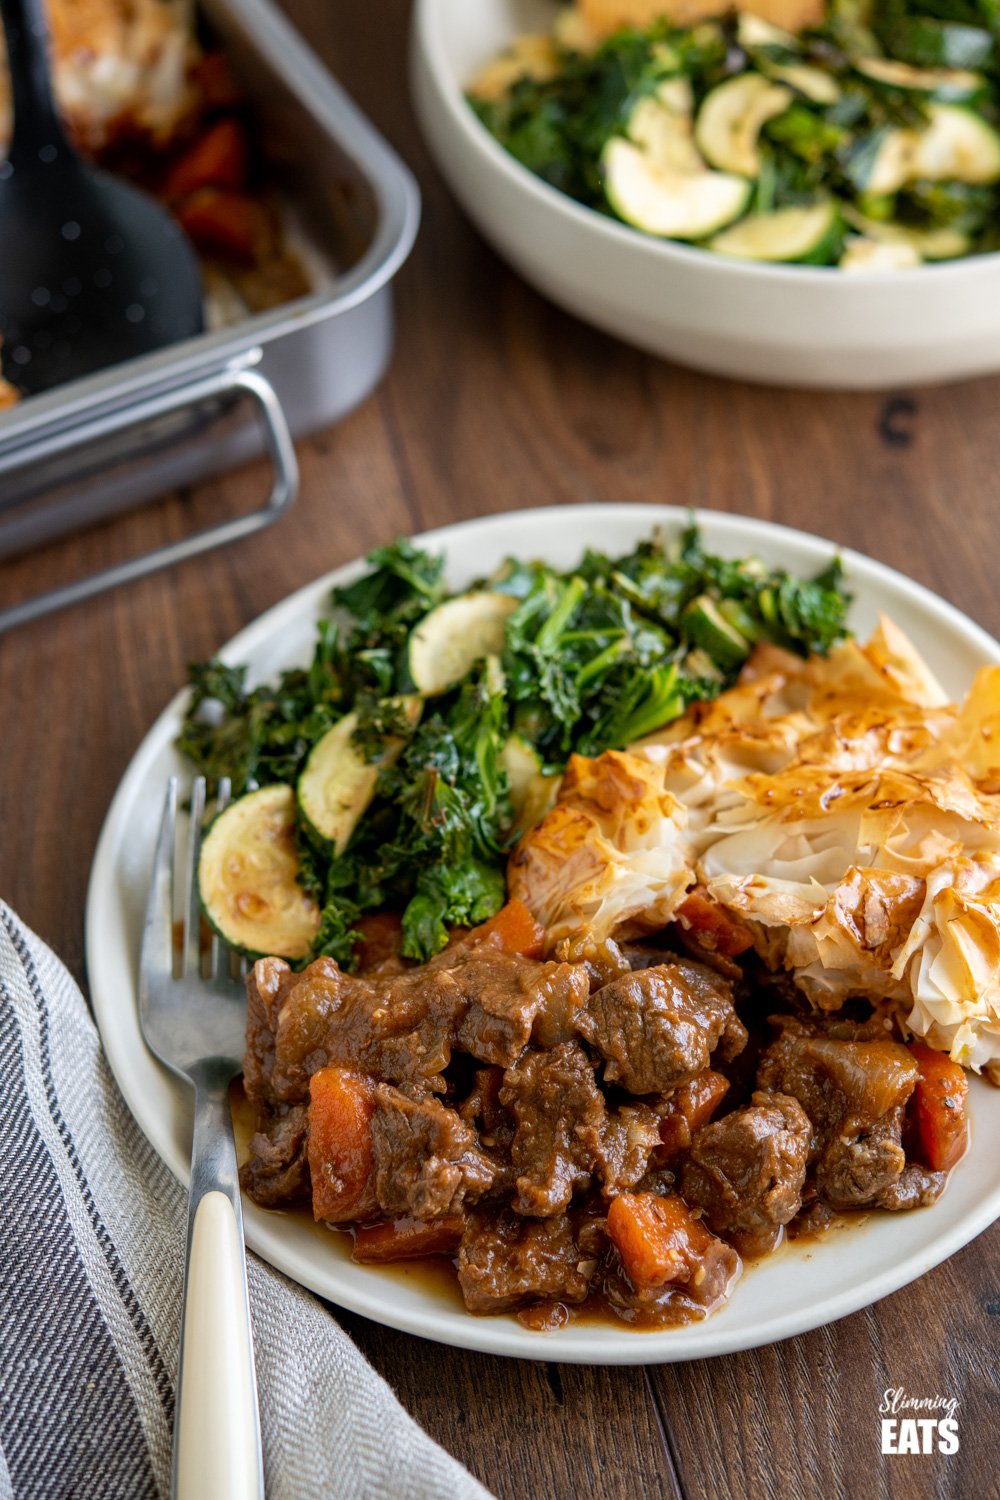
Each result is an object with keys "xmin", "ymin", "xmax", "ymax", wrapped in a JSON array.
[{"xmin": 457, "ymin": 951, "xmax": 591, "ymax": 1068}]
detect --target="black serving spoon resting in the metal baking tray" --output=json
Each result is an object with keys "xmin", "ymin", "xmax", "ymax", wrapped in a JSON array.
[{"xmin": 0, "ymin": 0, "xmax": 202, "ymax": 395}]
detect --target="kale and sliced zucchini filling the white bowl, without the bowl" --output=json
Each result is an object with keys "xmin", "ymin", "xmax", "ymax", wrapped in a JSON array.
[{"xmin": 469, "ymin": 0, "xmax": 1000, "ymax": 273}]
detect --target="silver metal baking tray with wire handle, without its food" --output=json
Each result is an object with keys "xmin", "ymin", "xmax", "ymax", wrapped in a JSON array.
[{"xmin": 0, "ymin": 0, "xmax": 420, "ymax": 632}]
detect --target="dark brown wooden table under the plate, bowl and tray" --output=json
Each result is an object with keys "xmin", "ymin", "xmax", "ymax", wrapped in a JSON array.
[{"xmin": 0, "ymin": 0, "xmax": 1000, "ymax": 1500}]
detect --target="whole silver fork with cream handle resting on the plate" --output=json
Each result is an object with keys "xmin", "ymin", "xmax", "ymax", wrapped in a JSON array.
[{"xmin": 139, "ymin": 777, "xmax": 264, "ymax": 1500}]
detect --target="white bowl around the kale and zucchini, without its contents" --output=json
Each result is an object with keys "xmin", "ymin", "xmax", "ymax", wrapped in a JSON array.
[{"xmin": 412, "ymin": 0, "xmax": 1000, "ymax": 390}]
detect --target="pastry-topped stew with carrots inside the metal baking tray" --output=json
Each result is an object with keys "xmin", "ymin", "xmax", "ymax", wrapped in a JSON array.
[{"xmin": 0, "ymin": 0, "xmax": 312, "ymax": 399}]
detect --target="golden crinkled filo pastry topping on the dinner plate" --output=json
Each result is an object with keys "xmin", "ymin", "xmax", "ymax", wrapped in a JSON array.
[{"xmin": 510, "ymin": 618, "xmax": 1000, "ymax": 1083}]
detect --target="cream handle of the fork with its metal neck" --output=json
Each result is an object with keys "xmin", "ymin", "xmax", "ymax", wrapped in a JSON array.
[{"xmin": 174, "ymin": 1064, "xmax": 264, "ymax": 1500}]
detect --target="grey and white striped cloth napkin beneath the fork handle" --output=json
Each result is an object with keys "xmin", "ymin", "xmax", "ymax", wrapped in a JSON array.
[{"xmin": 0, "ymin": 903, "xmax": 490, "ymax": 1500}]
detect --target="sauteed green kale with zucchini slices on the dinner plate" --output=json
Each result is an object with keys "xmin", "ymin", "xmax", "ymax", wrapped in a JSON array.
[{"xmin": 178, "ymin": 527, "xmax": 849, "ymax": 965}]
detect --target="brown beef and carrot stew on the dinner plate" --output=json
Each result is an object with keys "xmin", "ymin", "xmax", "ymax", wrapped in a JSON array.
[{"xmin": 243, "ymin": 911, "xmax": 946, "ymax": 1328}]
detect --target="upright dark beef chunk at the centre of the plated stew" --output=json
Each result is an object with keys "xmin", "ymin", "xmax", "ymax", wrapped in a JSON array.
[{"xmin": 501, "ymin": 1041, "xmax": 604, "ymax": 1218}]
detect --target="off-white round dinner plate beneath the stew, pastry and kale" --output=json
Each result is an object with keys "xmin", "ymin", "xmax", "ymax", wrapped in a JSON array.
[{"xmin": 87, "ymin": 506, "xmax": 1000, "ymax": 1365}]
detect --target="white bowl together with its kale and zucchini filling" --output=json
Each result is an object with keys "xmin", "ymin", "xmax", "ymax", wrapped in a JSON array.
[{"xmin": 414, "ymin": 0, "xmax": 1000, "ymax": 389}]
